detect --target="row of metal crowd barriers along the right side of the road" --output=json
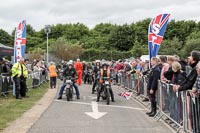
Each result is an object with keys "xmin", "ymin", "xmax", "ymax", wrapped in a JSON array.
[{"xmin": 113, "ymin": 72, "xmax": 200, "ymax": 133}]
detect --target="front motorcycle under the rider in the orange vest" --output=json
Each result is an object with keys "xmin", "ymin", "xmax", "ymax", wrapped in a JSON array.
[{"xmin": 100, "ymin": 77, "xmax": 111, "ymax": 105}]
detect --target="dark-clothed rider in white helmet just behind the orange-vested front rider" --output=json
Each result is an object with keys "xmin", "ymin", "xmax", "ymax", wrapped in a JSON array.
[{"xmin": 92, "ymin": 60, "xmax": 101, "ymax": 94}]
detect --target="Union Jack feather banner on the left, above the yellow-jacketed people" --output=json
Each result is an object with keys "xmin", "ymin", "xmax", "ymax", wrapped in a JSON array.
[{"xmin": 14, "ymin": 20, "xmax": 26, "ymax": 62}]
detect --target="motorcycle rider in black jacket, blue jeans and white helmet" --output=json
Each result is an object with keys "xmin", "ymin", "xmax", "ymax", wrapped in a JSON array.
[{"xmin": 57, "ymin": 61, "xmax": 80, "ymax": 99}]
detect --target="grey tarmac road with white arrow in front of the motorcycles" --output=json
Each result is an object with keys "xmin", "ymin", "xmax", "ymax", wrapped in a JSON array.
[{"xmin": 28, "ymin": 85, "xmax": 172, "ymax": 133}]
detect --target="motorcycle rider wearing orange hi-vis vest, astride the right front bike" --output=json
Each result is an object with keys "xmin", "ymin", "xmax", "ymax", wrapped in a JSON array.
[{"xmin": 97, "ymin": 62, "xmax": 115, "ymax": 102}]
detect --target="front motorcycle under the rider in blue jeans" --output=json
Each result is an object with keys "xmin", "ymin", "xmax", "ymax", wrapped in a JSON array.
[{"xmin": 64, "ymin": 76, "xmax": 75, "ymax": 101}]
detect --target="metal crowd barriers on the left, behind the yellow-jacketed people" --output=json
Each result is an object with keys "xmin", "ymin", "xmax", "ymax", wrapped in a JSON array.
[{"xmin": 0, "ymin": 72, "xmax": 48, "ymax": 97}]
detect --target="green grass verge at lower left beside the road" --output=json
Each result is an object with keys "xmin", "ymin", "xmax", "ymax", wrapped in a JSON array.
[{"xmin": 0, "ymin": 83, "xmax": 49, "ymax": 131}]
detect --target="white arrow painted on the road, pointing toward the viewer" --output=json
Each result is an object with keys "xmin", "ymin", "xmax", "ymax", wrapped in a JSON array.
[{"xmin": 85, "ymin": 101, "xmax": 107, "ymax": 120}]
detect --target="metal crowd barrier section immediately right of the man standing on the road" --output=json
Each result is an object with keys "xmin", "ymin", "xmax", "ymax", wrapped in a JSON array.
[{"xmin": 155, "ymin": 81, "xmax": 183, "ymax": 132}]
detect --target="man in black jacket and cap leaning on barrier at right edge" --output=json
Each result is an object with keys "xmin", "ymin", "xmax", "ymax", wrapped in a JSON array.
[{"xmin": 173, "ymin": 51, "xmax": 200, "ymax": 92}]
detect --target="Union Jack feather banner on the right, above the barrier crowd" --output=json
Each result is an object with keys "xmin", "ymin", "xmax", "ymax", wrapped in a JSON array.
[{"xmin": 148, "ymin": 14, "xmax": 170, "ymax": 60}]
